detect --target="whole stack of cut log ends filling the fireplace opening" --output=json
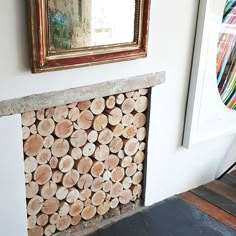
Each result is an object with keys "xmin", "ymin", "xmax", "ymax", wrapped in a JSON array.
[{"xmin": 22, "ymin": 89, "xmax": 148, "ymax": 236}]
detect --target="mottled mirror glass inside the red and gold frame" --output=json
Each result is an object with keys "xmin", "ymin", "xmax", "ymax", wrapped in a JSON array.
[{"xmin": 48, "ymin": 0, "xmax": 136, "ymax": 51}]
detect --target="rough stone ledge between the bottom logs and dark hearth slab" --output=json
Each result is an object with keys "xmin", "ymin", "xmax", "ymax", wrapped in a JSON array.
[{"xmin": 53, "ymin": 201, "xmax": 146, "ymax": 236}]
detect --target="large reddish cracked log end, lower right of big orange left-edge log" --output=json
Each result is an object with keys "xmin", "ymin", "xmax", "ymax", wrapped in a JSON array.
[{"xmin": 34, "ymin": 165, "xmax": 52, "ymax": 185}]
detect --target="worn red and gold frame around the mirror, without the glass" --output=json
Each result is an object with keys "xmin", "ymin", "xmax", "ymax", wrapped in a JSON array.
[{"xmin": 28, "ymin": 0, "xmax": 150, "ymax": 73}]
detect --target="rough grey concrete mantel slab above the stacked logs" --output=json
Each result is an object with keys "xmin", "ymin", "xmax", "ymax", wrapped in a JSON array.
[{"xmin": 0, "ymin": 72, "xmax": 165, "ymax": 117}]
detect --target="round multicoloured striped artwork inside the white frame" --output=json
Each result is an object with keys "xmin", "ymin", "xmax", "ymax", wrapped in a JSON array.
[{"xmin": 216, "ymin": 0, "xmax": 236, "ymax": 110}]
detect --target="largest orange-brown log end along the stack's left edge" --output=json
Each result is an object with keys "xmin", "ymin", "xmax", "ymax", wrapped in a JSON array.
[{"xmin": 24, "ymin": 134, "xmax": 43, "ymax": 156}]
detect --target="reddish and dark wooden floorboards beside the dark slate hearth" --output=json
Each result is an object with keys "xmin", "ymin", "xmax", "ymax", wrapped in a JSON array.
[{"xmin": 179, "ymin": 171, "xmax": 236, "ymax": 230}]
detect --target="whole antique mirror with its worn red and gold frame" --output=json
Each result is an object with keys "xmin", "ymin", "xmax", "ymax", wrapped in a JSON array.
[{"xmin": 29, "ymin": 0, "xmax": 150, "ymax": 73}]
